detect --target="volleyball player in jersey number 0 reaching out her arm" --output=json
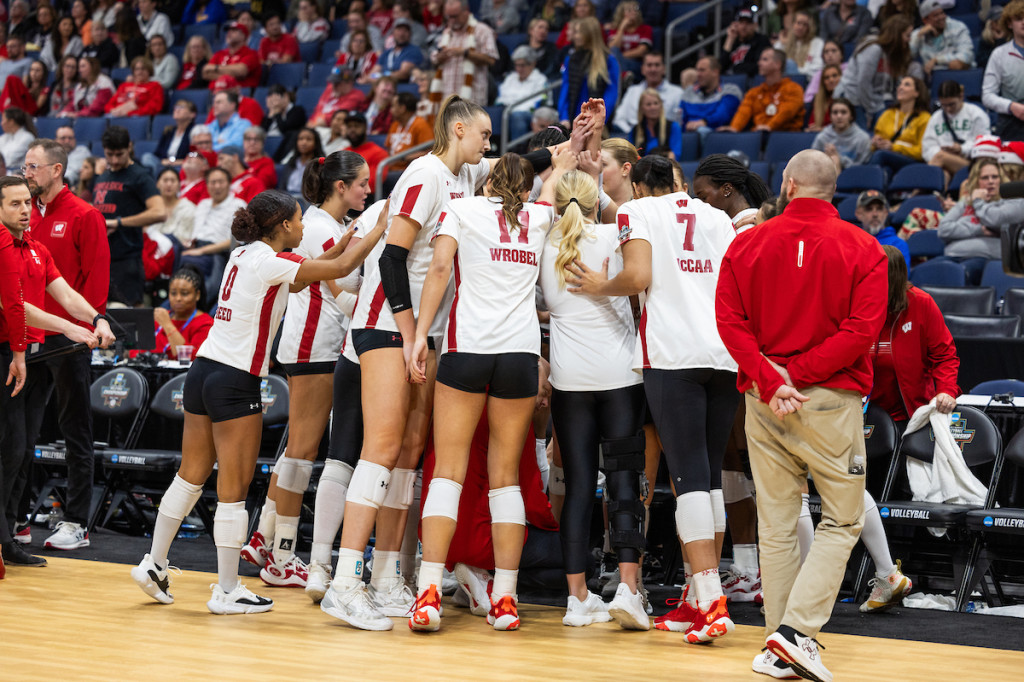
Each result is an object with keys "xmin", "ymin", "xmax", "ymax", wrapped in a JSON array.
[{"xmin": 131, "ymin": 189, "xmax": 384, "ymax": 614}]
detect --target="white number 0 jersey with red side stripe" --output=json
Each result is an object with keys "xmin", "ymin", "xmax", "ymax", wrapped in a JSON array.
[{"xmin": 196, "ymin": 242, "xmax": 305, "ymax": 377}]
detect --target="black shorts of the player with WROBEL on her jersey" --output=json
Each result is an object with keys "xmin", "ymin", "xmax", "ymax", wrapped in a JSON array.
[{"xmin": 437, "ymin": 353, "xmax": 539, "ymax": 400}]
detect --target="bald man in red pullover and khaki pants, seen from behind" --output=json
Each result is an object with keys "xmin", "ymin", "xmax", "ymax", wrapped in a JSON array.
[{"xmin": 716, "ymin": 150, "xmax": 888, "ymax": 681}]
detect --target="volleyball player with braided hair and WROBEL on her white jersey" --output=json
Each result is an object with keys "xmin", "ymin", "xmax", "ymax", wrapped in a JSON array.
[{"xmin": 409, "ymin": 153, "xmax": 575, "ymax": 632}]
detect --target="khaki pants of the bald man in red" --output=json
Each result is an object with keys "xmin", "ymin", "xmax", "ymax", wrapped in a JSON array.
[{"xmin": 745, "ymin": 387, "xmax": 864, "ymax": 637}]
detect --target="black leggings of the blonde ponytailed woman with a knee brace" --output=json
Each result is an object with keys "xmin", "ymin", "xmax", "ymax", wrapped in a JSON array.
[{"xmin": 551, "ymin": 384, "xmax": 643, "ymax": 574}]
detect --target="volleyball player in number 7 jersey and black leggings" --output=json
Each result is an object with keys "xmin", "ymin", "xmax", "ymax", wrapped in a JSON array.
[{"xmin": 567, "ymin": 156, "xmax": 739, "ymax": 644}]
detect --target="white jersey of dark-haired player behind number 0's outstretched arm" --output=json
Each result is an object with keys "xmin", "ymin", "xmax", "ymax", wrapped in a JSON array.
[{"xmin": 278, "ymin": 206, "xmax": 347, "ymax": 365}]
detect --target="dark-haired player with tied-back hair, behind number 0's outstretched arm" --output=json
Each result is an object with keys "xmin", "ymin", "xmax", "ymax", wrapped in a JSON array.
[{"xmin": 242, "ymin": 150, "xmax": 370, "ymax": 588}]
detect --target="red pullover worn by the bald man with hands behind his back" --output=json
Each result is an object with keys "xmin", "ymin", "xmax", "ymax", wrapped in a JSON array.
[{"xmin": 715, "ymin": 199, "xmax": 889, "ymax": 402}]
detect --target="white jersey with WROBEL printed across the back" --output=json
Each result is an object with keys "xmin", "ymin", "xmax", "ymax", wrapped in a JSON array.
[{"xmin": 434, "ymin": 197, "xmax": 555, "ymax": 355}]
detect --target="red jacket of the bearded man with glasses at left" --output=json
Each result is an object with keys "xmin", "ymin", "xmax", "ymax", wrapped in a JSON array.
[{"xmin": 31, "ymin": 185, "xmax": 111, "ymax": 336}]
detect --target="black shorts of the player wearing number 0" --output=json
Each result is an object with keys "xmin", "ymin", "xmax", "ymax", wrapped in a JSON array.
[{"xmin": 181, "ymin": 357, "xmax": 263, "ymax": 422}]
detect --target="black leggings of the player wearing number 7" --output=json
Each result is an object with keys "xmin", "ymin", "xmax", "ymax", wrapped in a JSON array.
[{"xmin": 643, "ymin": 370, "xmax": 739, "ymax": 496}]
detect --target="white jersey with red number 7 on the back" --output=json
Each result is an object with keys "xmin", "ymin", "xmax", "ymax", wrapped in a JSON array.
[{"xmin": 617, "ymin": 191, "xmax": 736, "ymax": 372}]
